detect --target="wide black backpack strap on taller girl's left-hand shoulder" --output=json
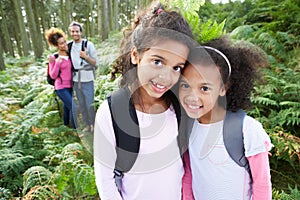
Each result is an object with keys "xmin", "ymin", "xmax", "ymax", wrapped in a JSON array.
[{"xmin": 107, "ymin": 88, "xmax": 140, "ymax": 173}]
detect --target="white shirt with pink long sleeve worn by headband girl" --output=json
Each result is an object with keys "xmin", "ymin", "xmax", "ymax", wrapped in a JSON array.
[{"xmin": 183, "ymin": 116, "xmax": 272, "ymax": 200}]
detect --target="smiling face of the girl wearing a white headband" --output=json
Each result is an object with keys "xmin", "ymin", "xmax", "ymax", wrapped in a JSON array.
[{"xmin": 179, "ymin": 64, "xmax": 226, "ymax": 122}]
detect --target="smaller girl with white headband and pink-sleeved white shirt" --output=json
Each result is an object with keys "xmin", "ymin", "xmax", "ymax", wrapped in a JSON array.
[{"xmin": 179, "ymin": 37, "xmax": 272, "ymax": 200}]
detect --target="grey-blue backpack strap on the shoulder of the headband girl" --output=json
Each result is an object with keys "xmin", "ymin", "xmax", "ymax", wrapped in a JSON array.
[{"xmin": 223, "ymin": 110, "xmax": 251, "ymax": 177}]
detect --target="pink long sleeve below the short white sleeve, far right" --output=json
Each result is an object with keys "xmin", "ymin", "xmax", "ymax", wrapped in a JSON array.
[{"xmin": 247, "ymin": 152, "xmax": 272, "ymax": 200}]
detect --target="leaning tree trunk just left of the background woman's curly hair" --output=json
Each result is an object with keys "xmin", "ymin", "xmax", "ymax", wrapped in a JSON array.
[{"xmin": 23, "ymin": 0, "xmax": 43, "ymax": 58}]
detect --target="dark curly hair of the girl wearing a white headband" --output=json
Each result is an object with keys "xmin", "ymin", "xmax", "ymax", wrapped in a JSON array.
[{"xmin": 188, "ymin": 36, "xmax": 269, "ymax": 112}]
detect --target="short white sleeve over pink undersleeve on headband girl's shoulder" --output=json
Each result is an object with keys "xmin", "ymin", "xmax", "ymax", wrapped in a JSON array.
[{"xmin": 243, "ymin": 116, "xmax": 272, "ymax": 157}]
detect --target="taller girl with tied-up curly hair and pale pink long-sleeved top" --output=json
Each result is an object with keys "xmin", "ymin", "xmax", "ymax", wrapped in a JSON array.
[{"xmin": 94, "ymin": 1, "xmax": 192, "ymax": 200}]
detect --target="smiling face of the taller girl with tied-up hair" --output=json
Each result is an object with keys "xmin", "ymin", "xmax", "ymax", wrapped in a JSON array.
[{"xmin": 131, "ymin": 40, "xmax": 189, "ymax": 98}]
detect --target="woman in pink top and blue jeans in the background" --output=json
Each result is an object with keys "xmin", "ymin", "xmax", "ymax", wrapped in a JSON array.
[{"xmin": 45, "ymin": 27, "xmax": 75, "ymax": 128}]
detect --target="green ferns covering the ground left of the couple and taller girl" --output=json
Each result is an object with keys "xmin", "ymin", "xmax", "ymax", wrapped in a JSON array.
[{"xmin": 0, "ymin": 55, "xmax": 97, "ymax": 199}]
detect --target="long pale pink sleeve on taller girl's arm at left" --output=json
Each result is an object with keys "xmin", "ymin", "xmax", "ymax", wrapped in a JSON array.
[{"xmin": 94, "ymin": 100, "xmax": 122, "ymax": 200}]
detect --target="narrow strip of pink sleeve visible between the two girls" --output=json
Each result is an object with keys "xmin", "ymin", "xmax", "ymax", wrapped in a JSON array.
[{"xmin": 182, "ymin": 151, "xmax": 194, "ymax": 200}]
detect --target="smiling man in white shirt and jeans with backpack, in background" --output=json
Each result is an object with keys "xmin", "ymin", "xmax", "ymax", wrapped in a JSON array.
[{"xmin": 68, "ymin": 22, "xmax": 98, "ymax": 132}]
